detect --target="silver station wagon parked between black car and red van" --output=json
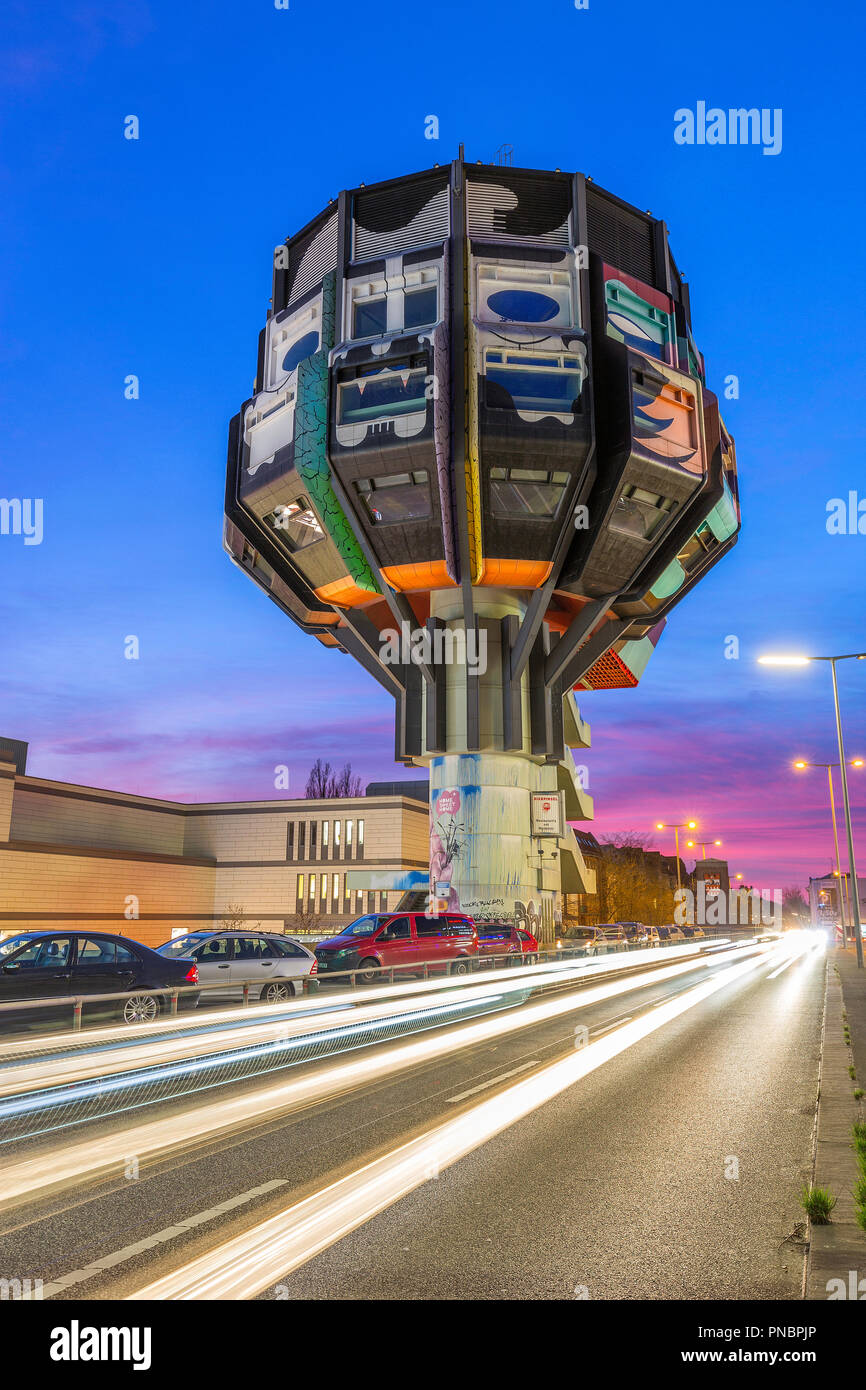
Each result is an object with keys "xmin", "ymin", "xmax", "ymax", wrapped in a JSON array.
[{"xmin": 157, "ymin": 931, "xmax": 318, "ymax": 1004}]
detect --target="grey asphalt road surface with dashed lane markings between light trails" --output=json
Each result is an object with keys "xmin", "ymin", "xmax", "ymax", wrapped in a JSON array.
[{"xmin": 0, "ymin": 939, "xmax": 824, "ymax": 1300}]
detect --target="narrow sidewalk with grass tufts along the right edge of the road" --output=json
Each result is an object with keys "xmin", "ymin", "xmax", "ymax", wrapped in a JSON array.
[{"xmin": 805, "ymin": 947, "xmax": 866, "ymax": 1300}]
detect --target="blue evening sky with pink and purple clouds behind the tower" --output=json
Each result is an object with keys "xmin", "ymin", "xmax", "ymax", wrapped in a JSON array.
[{"xmin": 0, "ymin": 0, "xmax": 866, "ymax": 885}]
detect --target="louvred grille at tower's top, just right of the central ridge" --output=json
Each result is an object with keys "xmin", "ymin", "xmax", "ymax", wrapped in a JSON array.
[{"xmin": 466, "ymin": 171, "xmax": 571, "ymax": 246}]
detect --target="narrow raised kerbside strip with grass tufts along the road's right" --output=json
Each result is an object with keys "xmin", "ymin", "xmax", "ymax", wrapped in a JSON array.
[{"xmin": 803, "ymin": 958, "xmax": 866, "ymax": 1301}]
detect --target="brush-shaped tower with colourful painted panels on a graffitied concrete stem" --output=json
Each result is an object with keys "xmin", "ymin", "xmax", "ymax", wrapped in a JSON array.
[{"xmin": 225, "ymin": 150, "xmax": 740, "ymax": 938}]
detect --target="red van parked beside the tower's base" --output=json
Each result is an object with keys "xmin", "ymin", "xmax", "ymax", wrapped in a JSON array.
[{"xmin": 316, "ymin": 912, "xmax": 478, "ymax": 984}]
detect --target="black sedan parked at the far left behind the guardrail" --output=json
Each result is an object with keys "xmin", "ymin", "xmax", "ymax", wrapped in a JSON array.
[{"xmin": 0, "ymin": 931, "xmax": 199, "ymax": 1033}]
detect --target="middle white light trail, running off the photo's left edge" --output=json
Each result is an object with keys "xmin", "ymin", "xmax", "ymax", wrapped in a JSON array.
[{"xmin": 0, "ymin": 945, "xmax": 771, "ymax": 1208}]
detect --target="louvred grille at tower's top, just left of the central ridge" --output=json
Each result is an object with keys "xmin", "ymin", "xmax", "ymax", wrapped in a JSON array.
[{"xmin": 352, "ymin": 172, "xmax": 450, "ymax": 260}]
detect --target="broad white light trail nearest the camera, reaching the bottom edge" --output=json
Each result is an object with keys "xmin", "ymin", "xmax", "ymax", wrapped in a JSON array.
[{"xmin": 129, "ymin": 939, "xmax": 795, "ymax": 1301}]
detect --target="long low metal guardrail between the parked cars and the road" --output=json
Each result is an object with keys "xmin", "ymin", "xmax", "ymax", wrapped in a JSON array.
[{"xmin": 0, "ymin": 931, "xmax": 727, "ymax": 1033}]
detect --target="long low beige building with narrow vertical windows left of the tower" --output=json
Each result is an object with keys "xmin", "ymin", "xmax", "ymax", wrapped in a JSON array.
[{"xmin": 0, "ymin": 741, "xmax": 428, "ymax": 947}]
